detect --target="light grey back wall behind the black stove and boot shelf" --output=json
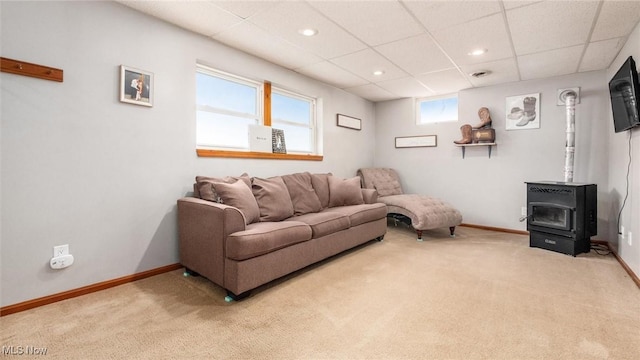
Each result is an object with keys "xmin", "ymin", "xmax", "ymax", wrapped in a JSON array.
[{"xmin": 375, "ymin": 71, "xmax": 611, "ymax": 238}]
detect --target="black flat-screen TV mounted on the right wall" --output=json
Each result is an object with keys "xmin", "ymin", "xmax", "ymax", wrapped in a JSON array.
[{"xmin": 609, "ymin": 56, "xmax": 640, "ymax": 132}]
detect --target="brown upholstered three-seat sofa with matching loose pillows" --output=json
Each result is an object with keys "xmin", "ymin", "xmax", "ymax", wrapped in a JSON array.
[{"xmin": 178, "ymin": 172, "xmax": 387, "ymax": 301}]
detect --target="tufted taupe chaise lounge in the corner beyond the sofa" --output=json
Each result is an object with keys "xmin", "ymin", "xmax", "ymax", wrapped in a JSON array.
[{"xmin": 358, "ymin": 168, "xmax": 462, "ymax": 241}]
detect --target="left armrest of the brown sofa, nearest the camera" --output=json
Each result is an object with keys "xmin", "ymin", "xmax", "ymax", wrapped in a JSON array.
[{"xmin": 178, "ymin": 197, "xmax": 245, "ymax": 287}]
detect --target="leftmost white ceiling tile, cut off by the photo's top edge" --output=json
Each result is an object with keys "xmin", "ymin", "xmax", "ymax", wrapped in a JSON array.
[{"xmin": 119, "ymin": 1, "xmax": 242, "ymax": 36}]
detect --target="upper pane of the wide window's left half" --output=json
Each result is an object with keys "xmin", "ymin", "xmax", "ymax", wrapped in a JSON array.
[{"xmin": 196, "ymin": 72, "xmax": 258, "ymax": 114}]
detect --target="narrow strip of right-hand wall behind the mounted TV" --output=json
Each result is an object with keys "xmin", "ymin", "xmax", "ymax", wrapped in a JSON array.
[{"xmin": 607, "ymin": 24, "xmax": 640, "ymax": 276}]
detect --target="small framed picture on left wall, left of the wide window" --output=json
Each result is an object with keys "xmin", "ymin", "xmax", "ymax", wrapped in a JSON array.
[{"xmin": 120, "ymin": 65, "xmax": 153, "ymax": 106}]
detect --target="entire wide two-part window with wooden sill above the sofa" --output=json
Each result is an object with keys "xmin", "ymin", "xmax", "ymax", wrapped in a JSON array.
[{"xmin": 196, "ymin": 65, "xmax": 322, "ymax": 160}]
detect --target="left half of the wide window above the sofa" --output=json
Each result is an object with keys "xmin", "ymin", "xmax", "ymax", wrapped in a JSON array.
[{"xmin": 196, "ymin": 67, "xmax": 262, "ymax": 150}]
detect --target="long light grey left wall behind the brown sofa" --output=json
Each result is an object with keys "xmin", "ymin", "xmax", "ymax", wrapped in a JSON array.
[{"xmin": 0, "ymin": 2, "xmax": 375, "ymax": 306}]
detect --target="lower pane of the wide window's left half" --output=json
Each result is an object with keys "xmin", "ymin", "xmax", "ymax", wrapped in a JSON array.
[{"xmin": 196, "ymin": 111, "xmax": 256, "ymax": 149}]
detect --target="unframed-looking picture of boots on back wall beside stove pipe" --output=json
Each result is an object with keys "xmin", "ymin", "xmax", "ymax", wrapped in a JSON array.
[{"xmin": 505, "ymin": 93, "xmax": 540, "ymax": 130}]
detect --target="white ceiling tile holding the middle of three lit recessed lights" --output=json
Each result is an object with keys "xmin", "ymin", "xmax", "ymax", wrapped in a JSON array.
[{"xmin": 331, "ymin": 49, "xmax": 407, "ymax": 82}]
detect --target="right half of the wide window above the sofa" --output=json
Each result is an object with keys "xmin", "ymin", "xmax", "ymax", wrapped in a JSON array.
[{"xmin": 271, "ymin": 88, "xmax": 316, "ymax": 154}]
